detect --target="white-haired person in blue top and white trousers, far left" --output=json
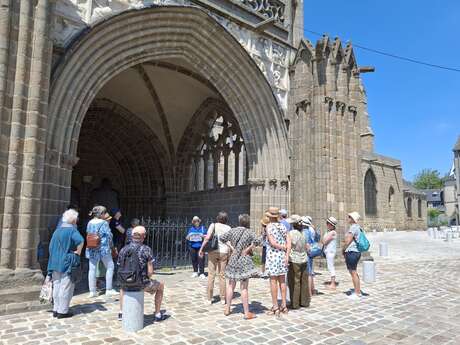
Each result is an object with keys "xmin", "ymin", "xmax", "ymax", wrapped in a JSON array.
[{"xmin": 48, "ymin": 209, "xmax": 84, "ymax": 319}]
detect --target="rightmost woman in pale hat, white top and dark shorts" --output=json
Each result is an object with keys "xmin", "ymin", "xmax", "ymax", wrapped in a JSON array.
[{"xmin": 342, "ymin": 212, "xmax": 361, "ymax": 300}]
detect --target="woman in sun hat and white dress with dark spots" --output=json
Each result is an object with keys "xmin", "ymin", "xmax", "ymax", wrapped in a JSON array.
[{"xmin": 265, "ymin": 207, "xmax": 291, "ymax": 315}]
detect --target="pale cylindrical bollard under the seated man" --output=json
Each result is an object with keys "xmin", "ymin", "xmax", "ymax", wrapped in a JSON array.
[{"xmin": 122, "ymin": 290, "xmax": 144, "ymax": 332}]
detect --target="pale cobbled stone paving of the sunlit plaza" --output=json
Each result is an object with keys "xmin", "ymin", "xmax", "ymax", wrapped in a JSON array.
[{"xmin": 0, "ymin": 232, "xmax": 460, "ymax": 345}]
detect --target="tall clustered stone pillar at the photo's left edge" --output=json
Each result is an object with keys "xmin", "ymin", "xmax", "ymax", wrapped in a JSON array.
[{"xmin": 0, "ymin": 0, "xmax": 52, "ymax": 310}]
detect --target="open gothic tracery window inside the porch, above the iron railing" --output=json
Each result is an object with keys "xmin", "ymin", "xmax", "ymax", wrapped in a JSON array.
[{"xmin": 191, "ymin": 111, "xmax": 247, "ymax": 191}]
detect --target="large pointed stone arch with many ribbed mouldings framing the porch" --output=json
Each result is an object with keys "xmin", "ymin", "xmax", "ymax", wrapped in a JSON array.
[{"xmin": 42, "ymin": 7, "xmax": 289, "ymax": 231}]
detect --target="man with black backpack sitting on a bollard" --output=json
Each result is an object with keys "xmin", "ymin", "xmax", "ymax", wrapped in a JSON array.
[{"xmin": 118, "ymin": 226, "xmax": 166, "ymax": 321}]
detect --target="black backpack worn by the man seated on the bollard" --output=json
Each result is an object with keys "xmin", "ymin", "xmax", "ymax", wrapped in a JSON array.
[{"xmin": 118, "ymin": 245, "xmax": 144, "ymax": 291}]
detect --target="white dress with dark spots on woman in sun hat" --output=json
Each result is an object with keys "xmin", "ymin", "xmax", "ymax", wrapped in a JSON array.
[{"xmin": 265, "ymin": 223, "xmax": 288, "ymax": 277}]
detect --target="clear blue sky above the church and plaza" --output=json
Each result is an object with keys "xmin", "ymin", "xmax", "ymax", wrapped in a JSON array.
[{"xmin": 304, "ymin": 0, "xmax": 460, "ymax": 180}]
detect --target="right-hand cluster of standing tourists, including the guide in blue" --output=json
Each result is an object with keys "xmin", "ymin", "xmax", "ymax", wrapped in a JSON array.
[{"xmin": 186, "ymin": 207, "xmax": 362, "ymax": 319}]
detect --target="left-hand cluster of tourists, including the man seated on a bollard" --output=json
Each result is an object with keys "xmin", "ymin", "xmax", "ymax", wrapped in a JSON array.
[{"xmin": 48, "ymin": 206, "xmax": 166, "ymax": 321}]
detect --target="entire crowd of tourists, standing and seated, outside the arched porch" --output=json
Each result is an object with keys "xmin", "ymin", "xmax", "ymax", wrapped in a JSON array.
[{"xmin": 48, "ymin": 206, "xmax": 362, "ymax": 321}]
